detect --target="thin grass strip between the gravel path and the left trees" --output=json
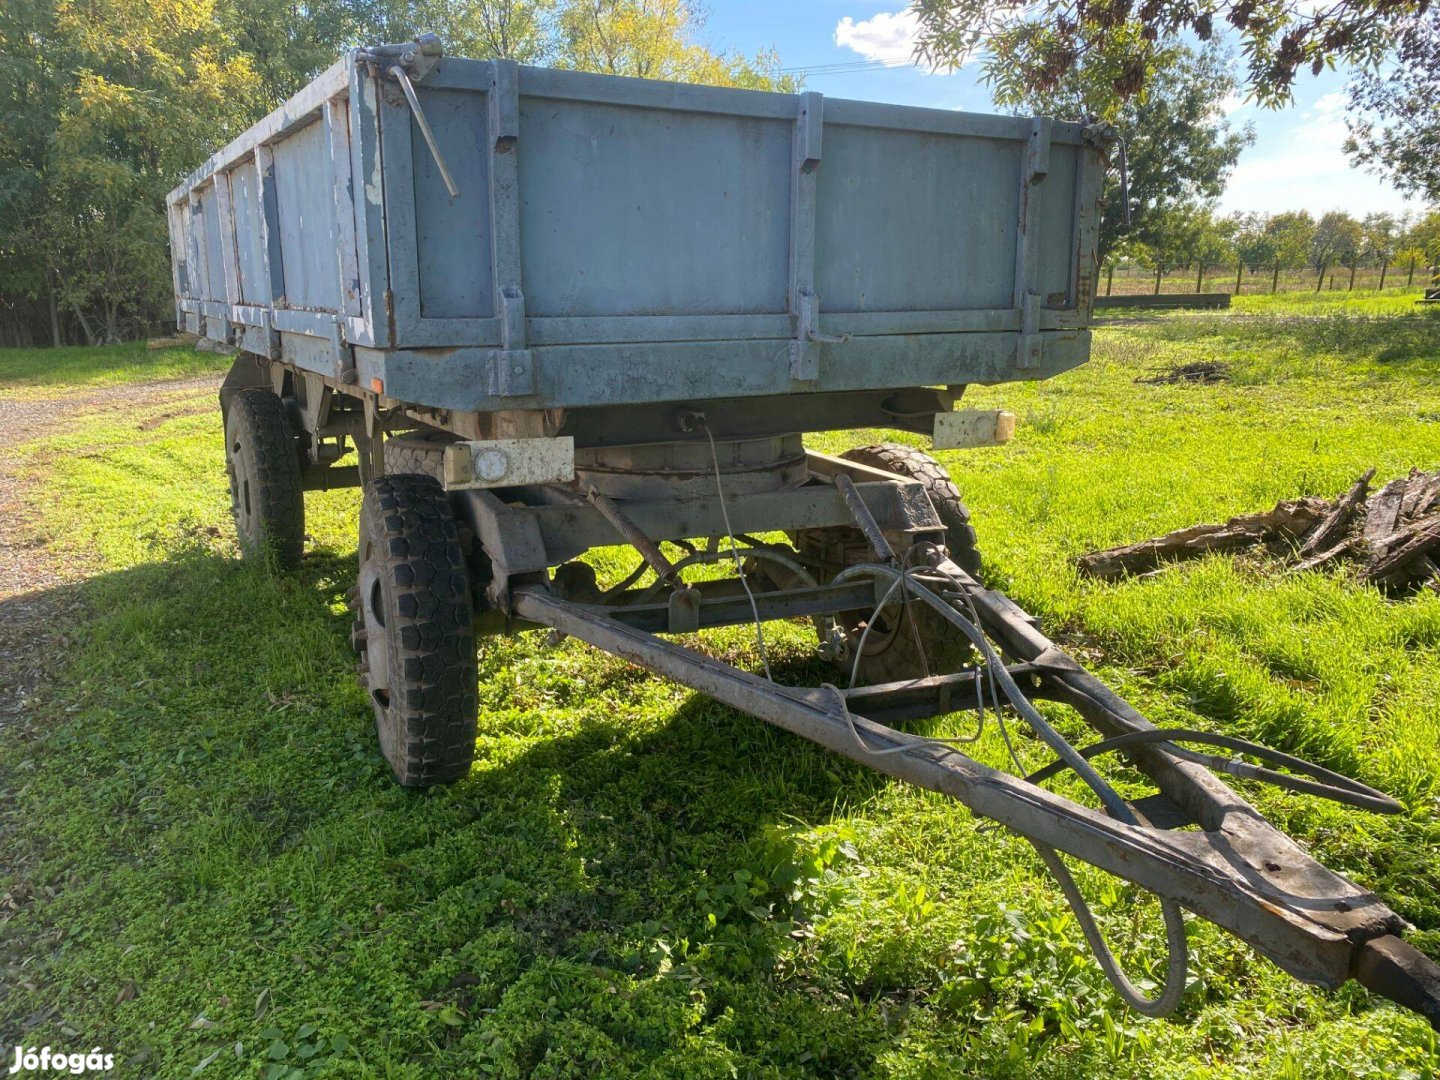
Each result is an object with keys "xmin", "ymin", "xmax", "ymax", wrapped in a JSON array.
[{"xmin": 0, "ymin": 341, "xmax": 230, "ymax": 399}]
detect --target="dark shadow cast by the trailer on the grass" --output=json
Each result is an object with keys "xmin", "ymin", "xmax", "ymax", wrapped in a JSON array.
[{"xmin": 0, "ymin": 550, "xmax": 910, "ymax": 1076}]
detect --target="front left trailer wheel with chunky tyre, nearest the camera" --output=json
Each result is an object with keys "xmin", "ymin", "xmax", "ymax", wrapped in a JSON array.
[{"xmin": 351, "ymin": 474, "xmax": 478, "ymax": 788}]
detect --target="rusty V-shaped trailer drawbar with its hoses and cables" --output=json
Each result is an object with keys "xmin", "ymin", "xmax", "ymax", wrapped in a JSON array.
[{"xmin": 498, "ymin": 500, "xmax": 1440, "ymax": 1030}]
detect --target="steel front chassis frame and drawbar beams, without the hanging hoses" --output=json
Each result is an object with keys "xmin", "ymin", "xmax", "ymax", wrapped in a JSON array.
[{"xmin": 451, "ymin": 452, "xmax": 1440, "ymax": 1030}]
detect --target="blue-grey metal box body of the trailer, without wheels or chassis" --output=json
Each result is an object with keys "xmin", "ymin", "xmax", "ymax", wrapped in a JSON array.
[{"xmin": 168, "ymin": 50, "xmax": 1103, "ymax": 412}]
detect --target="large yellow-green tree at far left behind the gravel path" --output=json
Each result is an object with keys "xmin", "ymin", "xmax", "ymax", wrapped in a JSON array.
[{"xmin": 0, "ymin": 0, "xmax": 264, "ymax": 344}]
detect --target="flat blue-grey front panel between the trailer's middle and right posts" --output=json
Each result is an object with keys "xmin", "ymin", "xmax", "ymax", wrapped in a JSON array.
[{"xmin": 815, "ymin": 124, "xmax": 1019, "ymax": 312}]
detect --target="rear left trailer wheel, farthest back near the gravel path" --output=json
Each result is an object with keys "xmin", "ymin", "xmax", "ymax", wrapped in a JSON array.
[{"xmin": 225, "ymin": 389, "xmax": 305, "ymax": 570}]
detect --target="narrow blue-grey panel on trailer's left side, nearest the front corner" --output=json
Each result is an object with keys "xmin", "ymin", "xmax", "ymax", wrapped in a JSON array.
[{"xmin": 272, "ymin": 120, "xmax": 340, "ymax": 311}]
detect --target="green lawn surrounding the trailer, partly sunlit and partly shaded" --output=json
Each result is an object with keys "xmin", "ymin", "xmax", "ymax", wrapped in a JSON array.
[{"xmin": 0, "ymin": 311, "xmax": 1440, "ymax": 1080}]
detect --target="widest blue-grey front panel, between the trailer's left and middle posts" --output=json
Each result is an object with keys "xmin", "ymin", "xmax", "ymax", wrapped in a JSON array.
[{"xmin": 518, "ymin": 96, "xmax": 791, "ymax": 318}]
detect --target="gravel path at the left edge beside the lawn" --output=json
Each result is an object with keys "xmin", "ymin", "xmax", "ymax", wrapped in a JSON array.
[{"xmin": 0, "ymin": 374, "xmax": 220, "ymax": 732}]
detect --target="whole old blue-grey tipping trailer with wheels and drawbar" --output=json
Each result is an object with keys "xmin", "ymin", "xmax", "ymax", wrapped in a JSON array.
[{"xmin": 168, "ymin": 35, "xmax": 1440, "ymax": 1025}]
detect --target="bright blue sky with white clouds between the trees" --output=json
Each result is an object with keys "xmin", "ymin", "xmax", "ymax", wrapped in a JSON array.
[{"xmin": 703, "ymin": 0, "xmax": 1421, "ymax": 216}]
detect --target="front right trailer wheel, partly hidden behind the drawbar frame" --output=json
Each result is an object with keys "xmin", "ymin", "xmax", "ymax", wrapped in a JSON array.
[{"xmin": 795, "ymin": 442, "xmax": 981, "ymax": 684}]
